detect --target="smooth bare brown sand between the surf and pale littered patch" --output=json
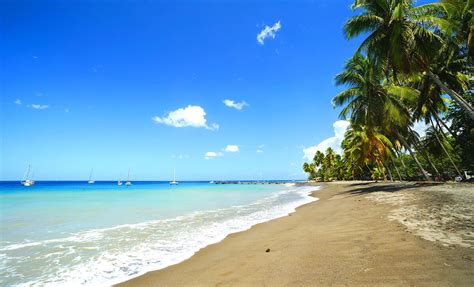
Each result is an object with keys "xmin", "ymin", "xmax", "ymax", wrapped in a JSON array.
[{"xmin": 114, "ymin": 183, "xmax": 474, "ymax": 286}]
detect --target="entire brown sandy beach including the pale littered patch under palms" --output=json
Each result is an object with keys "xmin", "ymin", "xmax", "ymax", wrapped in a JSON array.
[{"xmin": 117, "ymin": 183, "xmax": 474, "ymax": 286}]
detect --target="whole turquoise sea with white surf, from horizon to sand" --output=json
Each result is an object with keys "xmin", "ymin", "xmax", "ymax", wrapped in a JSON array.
[{"xmin": 0, "ymin": 182, "xmax": 315, "ymax": 286}]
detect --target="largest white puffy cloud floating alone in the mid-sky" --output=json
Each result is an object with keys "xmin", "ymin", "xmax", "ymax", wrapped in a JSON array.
[{"xmin": 152, "ymin": 105, "xmax": 219, "ymax": 130}]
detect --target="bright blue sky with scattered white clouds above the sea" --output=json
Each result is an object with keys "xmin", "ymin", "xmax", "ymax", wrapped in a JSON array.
[{"xmin": 0, "ymin": 0, "xmax": 359, "ymax": 180}]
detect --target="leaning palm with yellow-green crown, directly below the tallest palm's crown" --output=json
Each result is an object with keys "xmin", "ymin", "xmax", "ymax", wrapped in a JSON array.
[{"xmin": 332, "ymin": 53, "xmax": 428, "ymax": 179}]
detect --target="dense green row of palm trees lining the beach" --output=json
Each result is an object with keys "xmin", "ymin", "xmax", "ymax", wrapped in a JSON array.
[{"xmin": 303, "ymin": 0, "xmax": 474, "ymax": 180}]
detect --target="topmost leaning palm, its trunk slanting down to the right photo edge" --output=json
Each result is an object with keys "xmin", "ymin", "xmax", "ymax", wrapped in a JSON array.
[{"xmin": 344, "ymin": 0, "xmax": 474, "ymax": 118}]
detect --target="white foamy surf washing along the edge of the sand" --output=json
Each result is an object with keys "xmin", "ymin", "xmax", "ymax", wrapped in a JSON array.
[{"xmin": 0, "ymin": 186, "xmax": 318, "ymax": 286}]
